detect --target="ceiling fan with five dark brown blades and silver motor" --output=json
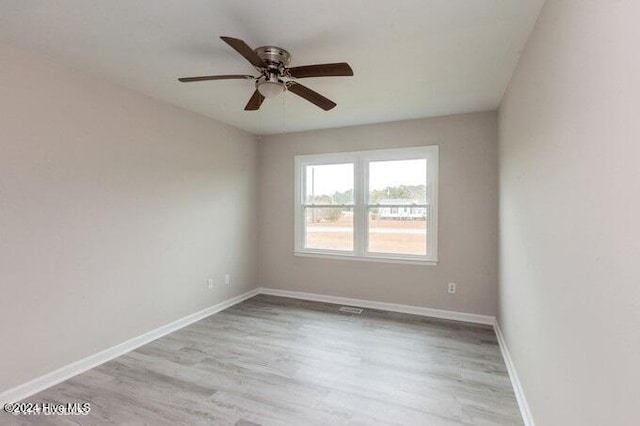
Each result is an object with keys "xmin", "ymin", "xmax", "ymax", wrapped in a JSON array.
[{"xmin": 178, "ymin": 37, "xmax": 353, "ymax": 111}]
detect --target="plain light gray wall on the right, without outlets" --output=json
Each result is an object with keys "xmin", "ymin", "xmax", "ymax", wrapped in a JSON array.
[{"xmin": 499, "ymin": 0, "xmax": 640, "ymax": 426}]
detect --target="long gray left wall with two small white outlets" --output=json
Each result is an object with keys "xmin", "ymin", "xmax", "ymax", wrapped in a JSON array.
[{"xmin": 0, "ymin": 45, "xmax": 257, "ymax": 392}]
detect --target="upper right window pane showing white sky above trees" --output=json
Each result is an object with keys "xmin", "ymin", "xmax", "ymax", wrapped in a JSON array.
[{"xmin": 369, "ymin": 158, "xmax": 429, "ymax": 204}]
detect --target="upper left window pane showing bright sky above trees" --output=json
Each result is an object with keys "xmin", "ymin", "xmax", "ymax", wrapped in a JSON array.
[{"xmin": 303, "ymin": 163, "xmax": 353, "ymax": 204}]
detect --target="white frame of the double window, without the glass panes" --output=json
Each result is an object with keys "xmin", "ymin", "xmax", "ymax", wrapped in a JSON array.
[{"xmin": 293, "ymin": 145, "xmax": 439, "ymax": 265}]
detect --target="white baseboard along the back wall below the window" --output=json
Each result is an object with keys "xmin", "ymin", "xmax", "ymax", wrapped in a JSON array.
[{"xmin": 259, "ymin": 287, "xmax": 496, "ymax": 325}]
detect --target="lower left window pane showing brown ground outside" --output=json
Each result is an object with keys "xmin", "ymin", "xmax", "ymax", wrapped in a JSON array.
[{"xmin": 305, "ymin": 207, "xmax": 353, "ymax": 251}]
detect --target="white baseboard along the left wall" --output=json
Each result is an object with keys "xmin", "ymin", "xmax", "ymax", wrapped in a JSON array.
[{"xmin": 0, "ymin": 289, "xmax": 258, "ymax": 405}]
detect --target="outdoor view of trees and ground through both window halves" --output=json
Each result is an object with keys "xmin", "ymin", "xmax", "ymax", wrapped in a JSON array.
[{"xmin": 304, "ymin": 159, "xmax": 429, "ymax": 255}]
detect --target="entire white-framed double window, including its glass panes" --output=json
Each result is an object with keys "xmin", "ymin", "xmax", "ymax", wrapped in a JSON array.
[{"xmin": 295, "ymin": 145, "xmax": 438, "ymax": 264}]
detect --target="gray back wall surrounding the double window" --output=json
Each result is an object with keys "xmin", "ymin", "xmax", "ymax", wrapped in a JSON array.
[{"xmin": 259, "ymin": 112, "xmax": 498, "ymax": 315}]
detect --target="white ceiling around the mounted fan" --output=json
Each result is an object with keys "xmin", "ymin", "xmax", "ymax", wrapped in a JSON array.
[{"xmin": 0, "ymin": 0, "xmax": 544, "ymax": 134}]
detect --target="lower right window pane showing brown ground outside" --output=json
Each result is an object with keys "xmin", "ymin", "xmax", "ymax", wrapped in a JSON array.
[{"xmin": 368, "ymin": 207, "xmax": 428, "ymax": 256}]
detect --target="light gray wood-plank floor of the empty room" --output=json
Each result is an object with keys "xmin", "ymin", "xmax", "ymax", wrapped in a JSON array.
[{"xmin": 0, "ymin": 295, "xmax": 522, "ymax": 426}]
